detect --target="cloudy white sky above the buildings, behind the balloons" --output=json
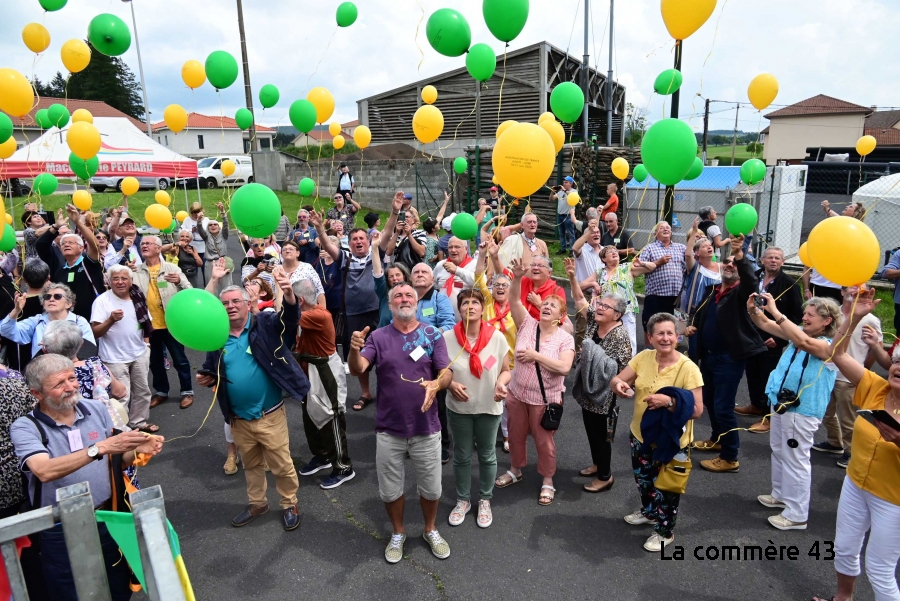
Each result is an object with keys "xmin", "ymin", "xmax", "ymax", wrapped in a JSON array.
[{"xmin": 0, "ymin": 0, "xmax": 900, "ymax": 131}]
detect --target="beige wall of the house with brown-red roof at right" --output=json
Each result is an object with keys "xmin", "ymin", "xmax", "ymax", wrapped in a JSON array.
[{"xmin": 763, "ymin": 113, "xmax": 866, "ymax": 165}]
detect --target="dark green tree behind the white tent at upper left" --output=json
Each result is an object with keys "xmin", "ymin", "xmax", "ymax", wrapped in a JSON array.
[{"xmin": 67, "ymin": 41, "xmax": 144, "ymax": 121}]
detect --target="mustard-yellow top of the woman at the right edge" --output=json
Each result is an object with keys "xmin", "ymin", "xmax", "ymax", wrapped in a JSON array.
[{"xmin": 847, "ymin": 370, "xmax": 900, "ymax": 505}]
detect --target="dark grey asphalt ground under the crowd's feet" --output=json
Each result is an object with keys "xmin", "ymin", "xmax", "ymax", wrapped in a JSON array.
[{"xmin": 138, "ymin": 286, "xmax": 892, "ymax": 601}]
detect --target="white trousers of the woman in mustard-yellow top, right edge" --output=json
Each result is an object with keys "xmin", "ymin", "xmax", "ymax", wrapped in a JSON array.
[{"xmin": 834, "ymin": 477, "xmax": 900, "ymax": 601}]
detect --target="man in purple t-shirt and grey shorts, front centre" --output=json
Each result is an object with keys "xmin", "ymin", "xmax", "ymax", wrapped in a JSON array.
[{"xmin": 347, "ymin": 284, "xmax": 453, "ymax": 563}]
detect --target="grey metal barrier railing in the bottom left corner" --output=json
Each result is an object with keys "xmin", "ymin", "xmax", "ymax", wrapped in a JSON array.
[{"xmin": 0, "ymin": 482, "xmax": 186, "ymax": 601}]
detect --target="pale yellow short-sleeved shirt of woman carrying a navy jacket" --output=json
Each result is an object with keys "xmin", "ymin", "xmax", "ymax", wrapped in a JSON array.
[{"xmin": 628, "ymin": 350, "xmax": 703, "ymax": 448}]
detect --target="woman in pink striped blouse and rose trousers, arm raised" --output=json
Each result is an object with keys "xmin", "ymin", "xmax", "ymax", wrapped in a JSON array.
[{"xmin": 495, "ymin": 259, "xmax": 575, "ymax": 505}]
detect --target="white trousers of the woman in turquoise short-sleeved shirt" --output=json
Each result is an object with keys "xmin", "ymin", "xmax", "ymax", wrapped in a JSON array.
[{"xmin": 769, "ymin": 411, "xmax": 821, "ymax": 522}]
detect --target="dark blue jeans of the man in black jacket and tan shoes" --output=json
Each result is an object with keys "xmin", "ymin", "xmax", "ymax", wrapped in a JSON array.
[{"xmin": 700, "ymin": 352, "xmax": 746, "ymax": 461}]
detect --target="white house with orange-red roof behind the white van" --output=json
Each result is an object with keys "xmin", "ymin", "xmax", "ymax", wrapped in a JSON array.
[{"xmin": 153, "ymin": 113, "xmax": 275, "ymax": 159}]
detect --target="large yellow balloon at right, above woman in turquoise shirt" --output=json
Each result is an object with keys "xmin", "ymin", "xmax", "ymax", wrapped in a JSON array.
[{"xmin": 806, "ymin": 215, "xmax": 881, "ymax": 286}]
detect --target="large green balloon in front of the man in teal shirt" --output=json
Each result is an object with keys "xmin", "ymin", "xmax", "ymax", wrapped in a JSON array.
[{"xmin": 166, "ymin": 288, "xmax": 230, "ymax": 353}]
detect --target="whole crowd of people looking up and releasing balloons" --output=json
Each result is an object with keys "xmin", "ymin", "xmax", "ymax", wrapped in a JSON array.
[{"xmin": 0, "ymin": 184, "xmax": 900, "ymax": 600}]
